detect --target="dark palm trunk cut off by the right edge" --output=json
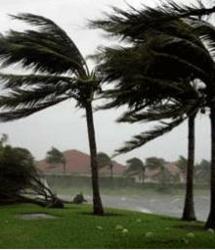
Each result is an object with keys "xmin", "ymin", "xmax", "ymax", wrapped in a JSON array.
[{"xmin": 205, "ymin": 104, "xmax": 215, "ymax": 229}]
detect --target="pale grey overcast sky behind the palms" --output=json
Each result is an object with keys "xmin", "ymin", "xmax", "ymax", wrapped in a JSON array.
[{"xmin": 0, "ymin": 0, "xmax": 210, "ymax": 163}]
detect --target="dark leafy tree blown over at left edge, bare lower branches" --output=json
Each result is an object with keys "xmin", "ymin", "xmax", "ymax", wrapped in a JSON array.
[{"xmin": 0, "ymin": 135, "xmax": 64, "ymax": 208}]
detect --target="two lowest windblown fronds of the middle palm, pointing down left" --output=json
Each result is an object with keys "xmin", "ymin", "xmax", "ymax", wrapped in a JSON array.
[{"xmin": 113, "ymin": 94, "xmax": 201, "ymax": 155}]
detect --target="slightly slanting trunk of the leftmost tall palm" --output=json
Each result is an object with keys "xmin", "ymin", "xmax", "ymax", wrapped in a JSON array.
[{"xmin": 86, "ymin": 103, "xmax": 104, "ymax": 215}]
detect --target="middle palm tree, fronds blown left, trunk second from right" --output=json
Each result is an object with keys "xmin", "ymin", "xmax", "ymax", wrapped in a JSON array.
[{"xmin": 92, "ymin": 24, "xmax": 207, "ymax": 220}]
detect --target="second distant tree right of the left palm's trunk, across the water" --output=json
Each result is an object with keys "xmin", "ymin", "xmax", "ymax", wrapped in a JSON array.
[{"xmin": 125, "ymin": 157, "xmax": 145, "ymax": 182}]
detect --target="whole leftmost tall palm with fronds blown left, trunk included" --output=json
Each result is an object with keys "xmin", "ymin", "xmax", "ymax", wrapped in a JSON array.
[{"xmin": 0, "ymin": 14, "xmax": 103, "ymax": 215}]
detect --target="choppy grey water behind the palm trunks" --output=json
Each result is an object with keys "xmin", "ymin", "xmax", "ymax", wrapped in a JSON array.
[{"xmin": 59, "ymin": 193, "xmax": 209, "ymax": 221}]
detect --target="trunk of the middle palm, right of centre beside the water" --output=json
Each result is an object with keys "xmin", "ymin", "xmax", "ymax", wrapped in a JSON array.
[{"xmin": 182, "ymin": 114, "xmax": 196, "ymax": 221}]
